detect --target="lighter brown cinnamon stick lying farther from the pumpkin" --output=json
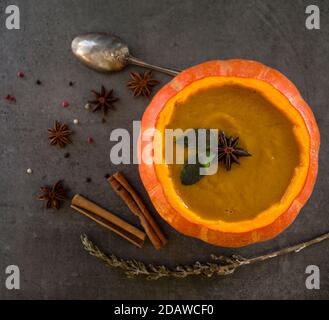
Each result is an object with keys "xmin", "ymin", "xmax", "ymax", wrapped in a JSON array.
[{"xmin": 71, "ymin": 194, "xmax": 146, "ymax": 248}]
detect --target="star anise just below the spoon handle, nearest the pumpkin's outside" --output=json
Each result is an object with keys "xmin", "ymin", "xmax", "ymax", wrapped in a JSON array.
[{"xmin": 128, "ymin": 71, "xmax": 160, "ymax": 97}]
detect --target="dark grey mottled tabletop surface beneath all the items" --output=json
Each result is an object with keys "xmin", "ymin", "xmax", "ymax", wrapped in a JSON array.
[{"xmin": 0, "ymin": 0, "xmax": 329, "ymax": 299}]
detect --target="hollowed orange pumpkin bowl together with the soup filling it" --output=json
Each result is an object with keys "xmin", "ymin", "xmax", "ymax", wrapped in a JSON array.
[{"xmin": 138, "ymin": 60, "xmax": 320, "ymax": 247}]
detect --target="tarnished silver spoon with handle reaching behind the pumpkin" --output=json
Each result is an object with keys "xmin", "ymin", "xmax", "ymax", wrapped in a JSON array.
[{"xmin": 72, "ymin": 33, "xmax": 179, "ymax": 76}]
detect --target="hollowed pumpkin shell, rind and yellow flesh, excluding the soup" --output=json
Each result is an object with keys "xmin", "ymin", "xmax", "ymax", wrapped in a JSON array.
[{"xmin": 138, "ymin": 60, "xmax": 320, "ymax": 247}]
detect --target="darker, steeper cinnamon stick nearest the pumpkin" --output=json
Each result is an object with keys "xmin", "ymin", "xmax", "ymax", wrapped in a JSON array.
[{"xmin": 108, "ymin": 172, "xmax": 168, "ymax": 250}]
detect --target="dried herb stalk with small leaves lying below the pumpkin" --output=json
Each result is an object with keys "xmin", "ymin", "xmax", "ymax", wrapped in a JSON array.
[{"xmin": 81, "ymin": 233, "xmax": 329, "ymax": 280}]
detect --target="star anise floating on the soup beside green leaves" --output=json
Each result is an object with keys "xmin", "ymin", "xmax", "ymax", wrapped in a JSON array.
[{"xmin": 218, "ymin": 131, "xmax": 251, "ymax": 170}]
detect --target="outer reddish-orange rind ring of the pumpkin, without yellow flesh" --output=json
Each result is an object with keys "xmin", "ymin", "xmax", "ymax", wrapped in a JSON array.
[{"xmin": 138, "ymin": 59, "xmax": 320, "ymax": 247}]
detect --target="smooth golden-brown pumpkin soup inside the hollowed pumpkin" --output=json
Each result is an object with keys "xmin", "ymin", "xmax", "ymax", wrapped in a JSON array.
[{"xmin": 160, "ymin": 85, "xmax": 300, "ymax": 221}]
